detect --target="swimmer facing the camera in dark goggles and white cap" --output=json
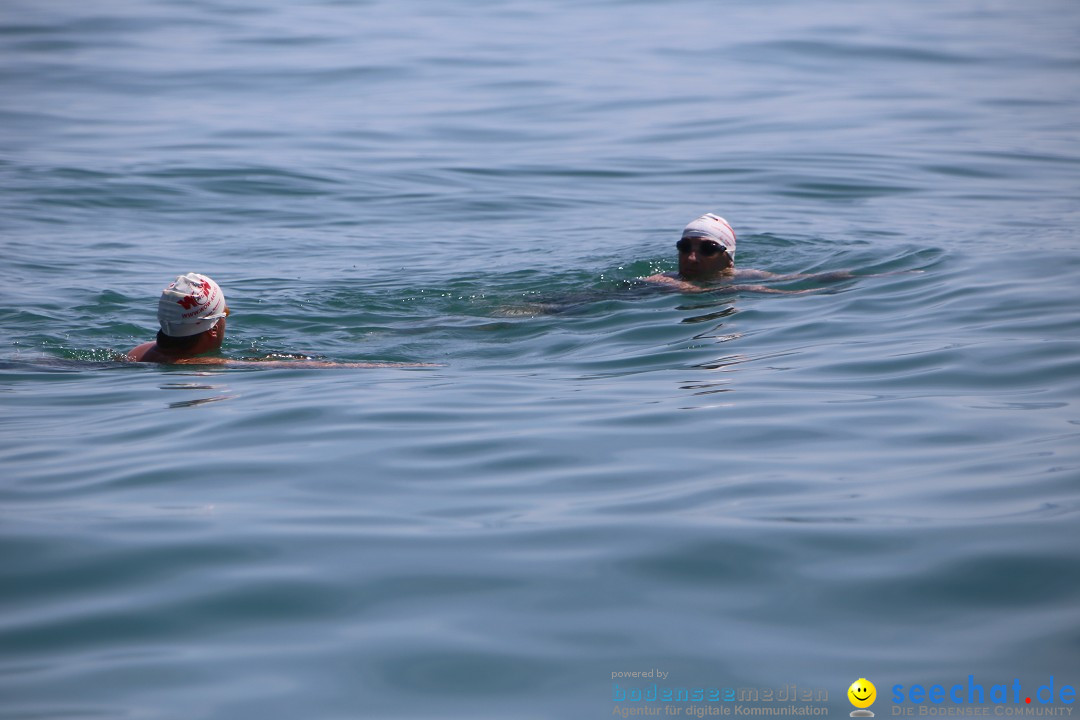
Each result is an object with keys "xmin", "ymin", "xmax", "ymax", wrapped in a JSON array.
[{"xmin": 642, "ymin": 213, "xmax": 854, "ymax": 295}]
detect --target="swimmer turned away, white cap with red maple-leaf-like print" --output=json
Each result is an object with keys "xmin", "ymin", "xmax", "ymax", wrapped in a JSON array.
[{"xmin": 124, "ymin": 272, "xmax": 432, "ymax": 367}]
